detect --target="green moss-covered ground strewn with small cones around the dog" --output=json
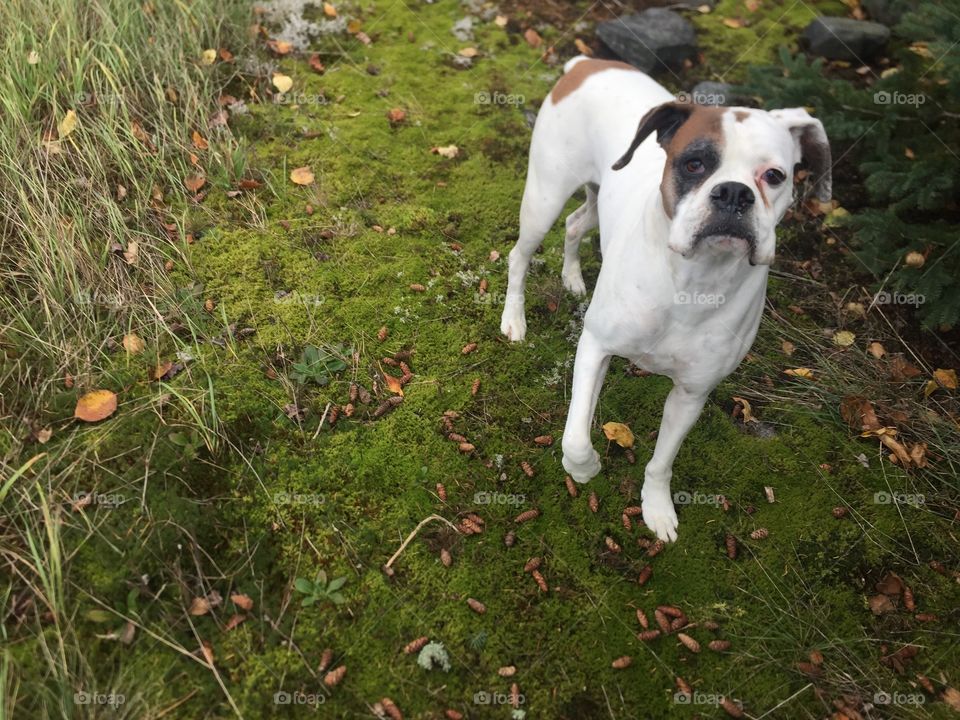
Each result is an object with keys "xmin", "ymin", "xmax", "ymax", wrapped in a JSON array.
[{"xmin": 9, "ymin": 2, "xmax": 960, "ymax": 719}]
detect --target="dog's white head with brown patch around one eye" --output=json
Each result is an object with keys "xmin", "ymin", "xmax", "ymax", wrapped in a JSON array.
[{"xmin": 613, "ymin": 102, "xmax": 831, "ymax": 265}]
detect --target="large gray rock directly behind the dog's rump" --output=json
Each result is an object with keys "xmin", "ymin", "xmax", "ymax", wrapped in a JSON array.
[{"xmin": 597, "ymin": 8, "xmax": 697, "ymax": 72}]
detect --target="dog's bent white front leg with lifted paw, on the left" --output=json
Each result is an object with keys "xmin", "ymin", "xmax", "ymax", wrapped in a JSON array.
[{"xmin": 563, "ymin": 329, "xmax": 610, "ymax": 483}]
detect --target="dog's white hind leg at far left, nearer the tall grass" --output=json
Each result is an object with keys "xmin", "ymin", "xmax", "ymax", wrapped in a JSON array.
[{"xmin": 500, "ymin": 167, "xmax": 580, "ymax": 342}]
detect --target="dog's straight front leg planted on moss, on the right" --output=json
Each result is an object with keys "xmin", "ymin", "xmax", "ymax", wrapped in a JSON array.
[{"xmin": 640, "ymin": 385, "xmax": 709, "ymax": 542}]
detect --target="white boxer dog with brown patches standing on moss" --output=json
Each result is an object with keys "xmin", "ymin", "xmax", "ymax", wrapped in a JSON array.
[{"xmin": 500, "ymin": 57, "xmax": 831, "ymax": 541}]
